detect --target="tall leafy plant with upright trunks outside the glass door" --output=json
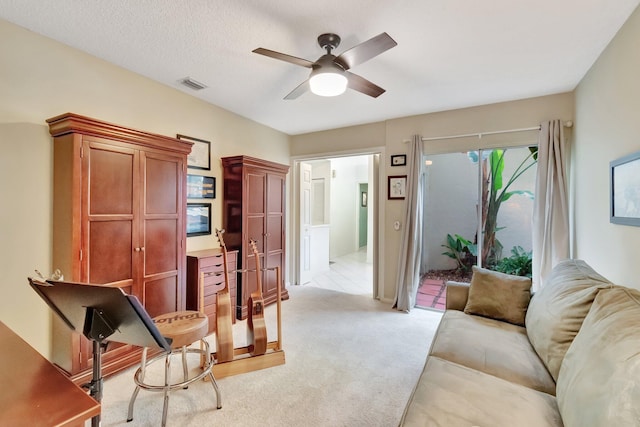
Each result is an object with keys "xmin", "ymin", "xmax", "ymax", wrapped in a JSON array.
[{"xmin": 467, "ymin": 147, "xmax": 538, "ymax": 267}]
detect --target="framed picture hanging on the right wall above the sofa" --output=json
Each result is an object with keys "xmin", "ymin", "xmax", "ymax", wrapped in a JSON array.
[{"xmin": 609, "ymin": 151, "xmax": 640, "ymax": 227}]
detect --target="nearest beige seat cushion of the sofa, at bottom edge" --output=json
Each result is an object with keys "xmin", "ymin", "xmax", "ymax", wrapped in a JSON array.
[{"xmin": 400, "ymin": 356, "xmax": 562, "ymax": 427}]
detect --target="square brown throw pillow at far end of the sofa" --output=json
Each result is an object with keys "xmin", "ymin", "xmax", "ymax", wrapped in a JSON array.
[{"xmin": 464, "ymin": 266, "xmax": 531, "ymax": 326}]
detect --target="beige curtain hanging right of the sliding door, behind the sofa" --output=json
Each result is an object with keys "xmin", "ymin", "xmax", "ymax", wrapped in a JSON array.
[{"xmin": 532, "ymin": 120, "xmax": 569, "ymax": 290}]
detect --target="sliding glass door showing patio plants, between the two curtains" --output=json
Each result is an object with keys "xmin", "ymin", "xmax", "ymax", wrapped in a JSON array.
[{"xmin": 416, "ymin": 147, "xmax": 537, "ymax": 309}]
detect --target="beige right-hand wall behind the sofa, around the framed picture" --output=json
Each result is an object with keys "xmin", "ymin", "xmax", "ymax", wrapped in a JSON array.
[{"xmin": 572, "ymin": 4, "xmax": 640, "ymax": 288}]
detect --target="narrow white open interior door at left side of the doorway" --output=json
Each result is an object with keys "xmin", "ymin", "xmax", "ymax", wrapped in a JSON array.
[{"xmin": 298, "ymin": 162, "xmax": 312, "ymax": 285}]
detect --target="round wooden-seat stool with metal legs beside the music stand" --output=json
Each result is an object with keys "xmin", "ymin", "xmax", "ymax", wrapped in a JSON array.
[{"xmin": 127, "ymin": 311, "xmax": 222, "ymax": 426}]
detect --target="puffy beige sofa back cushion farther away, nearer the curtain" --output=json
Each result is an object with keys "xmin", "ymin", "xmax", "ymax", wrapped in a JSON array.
[{"xmin": 526, "ymin": 260, "xmax": 612, "ymax": 380}]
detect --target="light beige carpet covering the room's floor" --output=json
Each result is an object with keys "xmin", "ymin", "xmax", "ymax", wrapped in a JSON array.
[{"xmin": 97, "ymin": 286, "xmax": 441, "ymax": 427}]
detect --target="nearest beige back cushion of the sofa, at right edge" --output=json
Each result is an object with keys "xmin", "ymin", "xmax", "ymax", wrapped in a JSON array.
[{"xmin": 557, "ymin": 287, "xmax": 640, "ymax": 427}]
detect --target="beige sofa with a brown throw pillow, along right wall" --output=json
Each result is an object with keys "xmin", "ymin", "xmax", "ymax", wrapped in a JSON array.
[{"xmin": 400, "ymin": 260, "xmax": 640, "ymax": 427}]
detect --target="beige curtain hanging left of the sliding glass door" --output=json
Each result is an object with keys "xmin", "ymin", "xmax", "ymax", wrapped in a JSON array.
[{"xmin": 393, "ymin": 135, "xmax": 424, "ymax": 312}]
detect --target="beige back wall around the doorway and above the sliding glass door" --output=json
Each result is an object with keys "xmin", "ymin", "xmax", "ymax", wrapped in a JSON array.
[{"xmin": 291, "ymin": 93, "xmax": 574, "ymax": 301}]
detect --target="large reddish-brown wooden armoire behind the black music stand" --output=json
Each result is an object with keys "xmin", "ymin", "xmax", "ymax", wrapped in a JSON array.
[{"xmin": 47, "ymin": 113, "xmax": 191, "ymax": 382}]
